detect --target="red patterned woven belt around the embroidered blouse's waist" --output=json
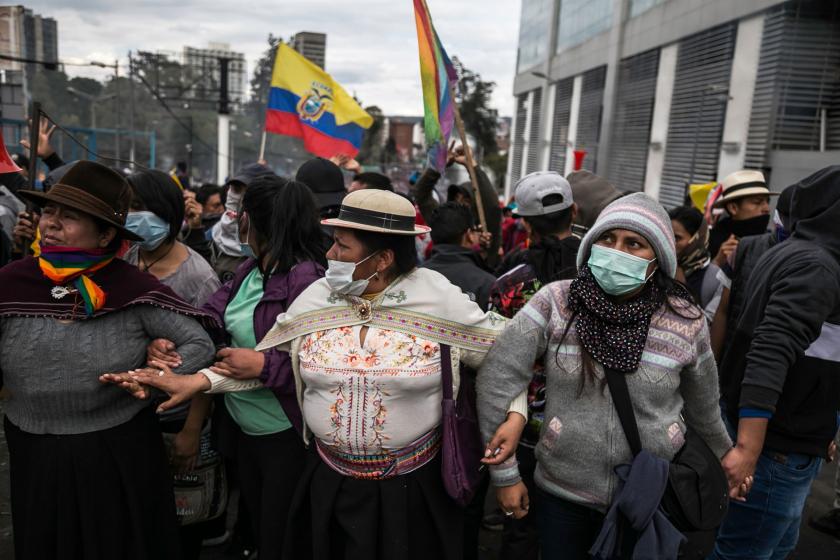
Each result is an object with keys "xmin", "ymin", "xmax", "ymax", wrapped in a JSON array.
[{"xmin": 315, "ymin": 428, "xmax": 441, "ymax": 480}]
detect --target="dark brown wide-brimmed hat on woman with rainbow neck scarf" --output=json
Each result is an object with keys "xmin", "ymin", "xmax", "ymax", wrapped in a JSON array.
[{"xmin": 18, "ymin": 161, "xmax": 143, "ymax": 241}]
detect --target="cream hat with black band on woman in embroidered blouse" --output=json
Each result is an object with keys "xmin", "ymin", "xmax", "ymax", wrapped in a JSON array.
[{"xmin": 321, "ymin": 189, "xmax": 432, "ymax": 235}]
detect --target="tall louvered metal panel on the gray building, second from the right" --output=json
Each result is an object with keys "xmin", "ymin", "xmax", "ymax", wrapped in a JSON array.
[{"xmin": 659, "ymin": 23, "xmax": 736, "ymax": 206}]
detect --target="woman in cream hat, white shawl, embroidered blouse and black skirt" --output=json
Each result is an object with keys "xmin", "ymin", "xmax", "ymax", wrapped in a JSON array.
[{"xmin": 126, "ymin": 189, "xmax": 524, "ymax": 559}]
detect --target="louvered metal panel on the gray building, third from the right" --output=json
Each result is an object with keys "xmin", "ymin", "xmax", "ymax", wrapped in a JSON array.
[{"xmin": 607, "ymin": 49, "xmax": 659, "ymax": 191}]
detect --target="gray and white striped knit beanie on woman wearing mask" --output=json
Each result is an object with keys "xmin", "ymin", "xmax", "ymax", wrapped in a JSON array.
[{"xmin": 577, "ymin": 193, "xmax": 677, "ymax": 278}]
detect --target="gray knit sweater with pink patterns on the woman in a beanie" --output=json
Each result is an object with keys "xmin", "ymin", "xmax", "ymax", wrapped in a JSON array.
[{"xmin": 477, "ymin": 280, "xmax": 732, "ymax": 511}]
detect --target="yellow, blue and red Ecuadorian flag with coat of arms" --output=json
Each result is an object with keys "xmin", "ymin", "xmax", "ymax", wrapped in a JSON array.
[{"xmin": 265, "ymin": 43, "xmax": 373, "ymax": 158}]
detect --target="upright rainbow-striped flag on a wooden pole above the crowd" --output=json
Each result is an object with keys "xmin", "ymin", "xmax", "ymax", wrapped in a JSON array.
[{"xmin": 414, "ymin": 0, "xmax": 458, "ymax": 171}]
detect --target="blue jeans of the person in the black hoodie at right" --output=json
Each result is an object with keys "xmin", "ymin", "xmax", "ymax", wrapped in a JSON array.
[{"xmin": 707, "ymin": 450, "xmax": 822, "ymax": 560}]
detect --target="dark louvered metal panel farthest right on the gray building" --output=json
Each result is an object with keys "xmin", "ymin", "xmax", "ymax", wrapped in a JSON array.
[{"xmin": 746, "ymin": 2, "xmax": 840, "ymax": 169}]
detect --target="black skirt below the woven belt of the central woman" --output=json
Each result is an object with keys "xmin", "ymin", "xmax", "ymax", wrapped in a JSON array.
[{"xmin": 284, "ymin": 445, "xmax": 464, "ymax": 560}]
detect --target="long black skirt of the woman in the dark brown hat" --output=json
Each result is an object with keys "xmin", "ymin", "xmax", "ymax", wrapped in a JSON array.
[{"xmin": 4, "ymin": 408, "xmax": 181, "ymax": 560}]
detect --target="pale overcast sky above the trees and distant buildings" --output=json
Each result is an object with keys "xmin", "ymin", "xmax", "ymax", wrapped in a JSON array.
[{"xmin": 25, "ymin": 0, "xmax": 520, "ymax": 116}]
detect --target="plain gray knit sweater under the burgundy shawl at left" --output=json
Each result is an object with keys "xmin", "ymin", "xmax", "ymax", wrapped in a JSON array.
[{"xmin": 0, "ymin": 305, "xmax": 214, "ymax": 434}]
